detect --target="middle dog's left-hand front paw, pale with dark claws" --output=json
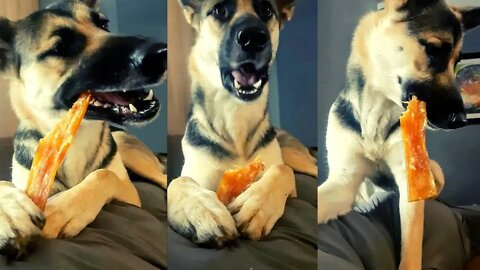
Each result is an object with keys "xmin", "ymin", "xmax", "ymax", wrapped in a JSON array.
[{"xmin": 167, "ymin": 177, "xmax": 238, "ymax": 246}]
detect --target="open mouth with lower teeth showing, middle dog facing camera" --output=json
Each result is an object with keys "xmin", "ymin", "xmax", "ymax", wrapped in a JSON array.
[{"xmin": 222, "ymin": 63, "xmax": 268, "ymax": 102}]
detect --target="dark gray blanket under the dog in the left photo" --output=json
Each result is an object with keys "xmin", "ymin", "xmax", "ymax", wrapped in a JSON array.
[{"xmin": 0, "ymin": 182, "xmax": 167, "ymax": 270}]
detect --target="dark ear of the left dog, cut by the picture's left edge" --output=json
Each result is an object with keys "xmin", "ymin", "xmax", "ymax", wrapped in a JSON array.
[{"xmin": 0, "ymin": 17, "xmax": 15, "ymax": 74}]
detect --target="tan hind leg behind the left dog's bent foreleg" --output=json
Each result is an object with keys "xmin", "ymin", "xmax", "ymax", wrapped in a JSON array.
[{"xmin": 112, "ymin": 131, "xmax": 167, "ymax": 189}]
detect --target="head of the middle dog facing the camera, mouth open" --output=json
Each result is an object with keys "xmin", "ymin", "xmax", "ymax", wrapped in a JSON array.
[{"xmin": 179, "ymin": 0, "xmax": 295, "ymax": 102}]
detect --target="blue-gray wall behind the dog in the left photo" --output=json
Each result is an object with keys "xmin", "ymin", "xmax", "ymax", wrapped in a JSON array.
[{"xmin": 40, "ymin": 0, "xmax": 167, "ymax": 153}]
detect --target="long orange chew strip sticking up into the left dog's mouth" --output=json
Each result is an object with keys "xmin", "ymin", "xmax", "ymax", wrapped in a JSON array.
[{"xmin": 26, "ymin": 94, "xmax": 92, "ymax": 210}]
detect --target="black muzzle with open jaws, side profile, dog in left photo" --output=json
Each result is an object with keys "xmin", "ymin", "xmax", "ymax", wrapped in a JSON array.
[{"xmin": 56, "ymin": 36, "xmax": 167, "ymax": 125}]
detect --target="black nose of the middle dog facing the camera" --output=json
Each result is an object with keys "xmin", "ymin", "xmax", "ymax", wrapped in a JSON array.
[{"xmin": 237, "ymin": 27, "xmax": 269, "ymax": 53}]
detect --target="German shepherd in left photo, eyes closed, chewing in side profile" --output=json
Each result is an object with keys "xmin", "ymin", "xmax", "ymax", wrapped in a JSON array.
[{"xmin": 0, "ymin": 0, "xmax": 166, "ymax": 254}]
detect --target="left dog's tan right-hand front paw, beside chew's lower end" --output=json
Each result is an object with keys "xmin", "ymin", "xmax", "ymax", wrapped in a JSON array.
[{"xmin": 42, "ymin": 189, "xmax": 105, "ymax": 239}]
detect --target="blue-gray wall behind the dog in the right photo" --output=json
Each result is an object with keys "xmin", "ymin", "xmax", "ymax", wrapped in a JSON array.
[{"xmin": 318, "ymin": 0, "xmax": 480, "ymax": 205}]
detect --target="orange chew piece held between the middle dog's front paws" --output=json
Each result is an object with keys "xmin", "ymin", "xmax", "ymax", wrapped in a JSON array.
[{"xmin": 217, "ymin": 159, "xmax": 265, "ymax": 205}]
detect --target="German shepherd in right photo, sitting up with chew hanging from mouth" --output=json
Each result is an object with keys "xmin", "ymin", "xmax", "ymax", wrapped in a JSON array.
[{"xmin": 318, "ymin": 0, "xmax": 480, "ymax": 270}]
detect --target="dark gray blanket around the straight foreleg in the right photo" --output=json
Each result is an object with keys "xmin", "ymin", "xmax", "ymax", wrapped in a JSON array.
[{"xmin": 318, "ymin": 192, "xmax": 480, "ymax": 270}]
